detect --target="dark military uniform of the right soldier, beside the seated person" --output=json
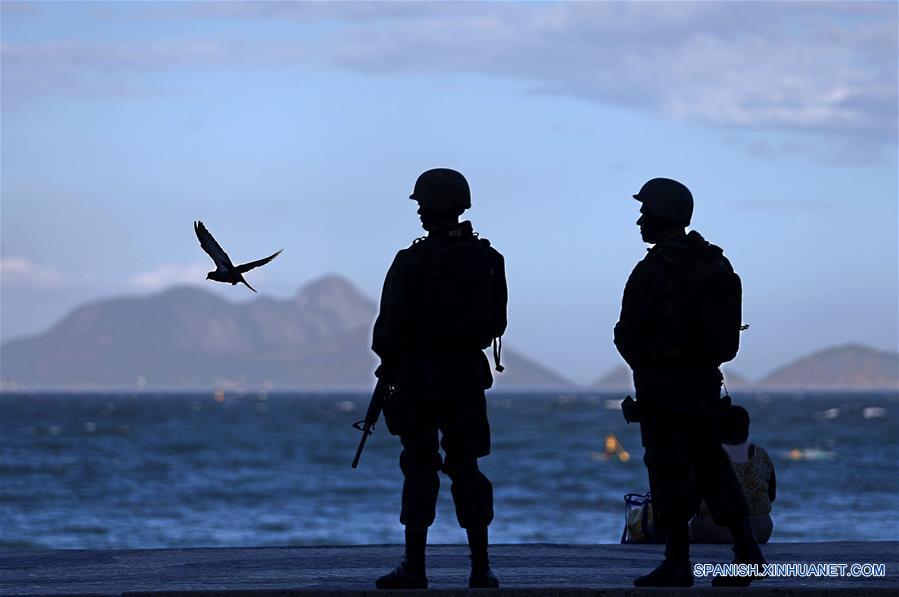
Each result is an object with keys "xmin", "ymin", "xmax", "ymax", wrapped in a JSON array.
[{"xmin": 615, "ymin": 231, "xmax": 755, "ymax": 562}]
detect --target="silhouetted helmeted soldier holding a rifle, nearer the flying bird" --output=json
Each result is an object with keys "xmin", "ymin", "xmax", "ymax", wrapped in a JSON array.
[{"xmin": 372, "ymin": 168, "xmax": 507, "ymax": 589}]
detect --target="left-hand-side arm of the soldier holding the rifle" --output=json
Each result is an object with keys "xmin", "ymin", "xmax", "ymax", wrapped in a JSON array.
[{"xmin": 371, "ymin": 249, "xmax": 413, "ymax": 383}]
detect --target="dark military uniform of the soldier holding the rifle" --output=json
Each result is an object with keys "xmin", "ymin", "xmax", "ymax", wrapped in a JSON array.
[{"xmin": 372, "ymin": 221, "xmax": 507, "ymax": 529}]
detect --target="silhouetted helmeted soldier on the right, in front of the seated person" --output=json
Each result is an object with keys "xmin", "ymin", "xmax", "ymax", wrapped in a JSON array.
[{"xmin": 615, "ymin": 178, "xmax": 764, "ymax": 586}]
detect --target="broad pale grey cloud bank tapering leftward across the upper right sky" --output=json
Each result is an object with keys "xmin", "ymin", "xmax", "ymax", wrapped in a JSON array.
[{"xmin": 318, "ymin": 3, "xmax": 897, "ymax": 143}]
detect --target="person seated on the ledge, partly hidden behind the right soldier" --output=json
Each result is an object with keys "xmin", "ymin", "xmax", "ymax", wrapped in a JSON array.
[{"xmin": 690, "ymin": 406, "xmax": 777, "ymax": 543}]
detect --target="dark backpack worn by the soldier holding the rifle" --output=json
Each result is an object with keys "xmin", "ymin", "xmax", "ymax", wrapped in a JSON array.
[{"xmin": 413, "ymin": 237, "xmax": 507, "ymax": 371}]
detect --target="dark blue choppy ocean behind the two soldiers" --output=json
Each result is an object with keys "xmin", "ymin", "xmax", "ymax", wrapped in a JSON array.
[{"xmin": 0, "ymin": 392, "xmax": 899, "ymax": 549}]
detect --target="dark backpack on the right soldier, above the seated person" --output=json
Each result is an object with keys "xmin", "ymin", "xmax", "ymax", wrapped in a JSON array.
[{"xmin": 666, "ymin": 244, "xmax": 748, "ymax": 365}]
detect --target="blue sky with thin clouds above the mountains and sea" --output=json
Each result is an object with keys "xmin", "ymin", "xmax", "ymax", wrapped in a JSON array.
[{"xmin": 0, "ymin": 1, "xmax": 899, "ymax": 383}]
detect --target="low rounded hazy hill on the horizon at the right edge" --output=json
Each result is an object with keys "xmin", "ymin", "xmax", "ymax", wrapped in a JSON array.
[{"xmin": 759, "ymin": 344, "xmax": 899, "ymax": 389}]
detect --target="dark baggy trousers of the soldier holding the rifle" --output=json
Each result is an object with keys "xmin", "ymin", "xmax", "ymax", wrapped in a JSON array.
[{"xmin": 400, "ymin": 393, "xmax": 493, "ymax": 529}]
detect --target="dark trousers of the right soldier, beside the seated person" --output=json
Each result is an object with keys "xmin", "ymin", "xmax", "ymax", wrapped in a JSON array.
[{"xmin": 644, "ymin": 411, "xmax": 757, "ymax": 561}]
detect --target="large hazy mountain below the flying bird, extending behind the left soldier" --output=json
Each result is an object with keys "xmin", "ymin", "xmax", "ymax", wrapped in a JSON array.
[{"xmin": 0, "ymin": 276, "xmax": 571, "ymax": 390}]
